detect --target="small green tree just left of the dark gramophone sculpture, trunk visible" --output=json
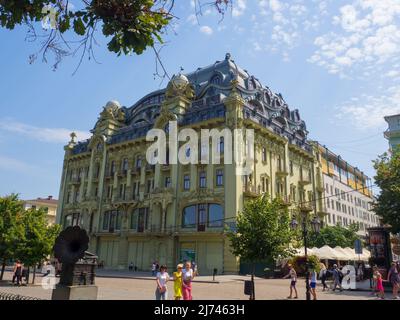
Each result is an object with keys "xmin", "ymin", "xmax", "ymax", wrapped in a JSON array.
[{"xmin": 16, "ymin": 209, "xmax": 60, "ymax": 281}]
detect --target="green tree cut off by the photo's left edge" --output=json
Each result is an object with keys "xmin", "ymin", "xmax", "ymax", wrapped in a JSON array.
[{"xmin": 0, "ymin": 194, "xmax": 23, "ymax": 280}]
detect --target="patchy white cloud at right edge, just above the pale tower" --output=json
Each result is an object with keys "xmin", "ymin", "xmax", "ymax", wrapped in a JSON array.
[{"xmin": 337, "ymin": 86, "xmax": 400, "ymax": 130}]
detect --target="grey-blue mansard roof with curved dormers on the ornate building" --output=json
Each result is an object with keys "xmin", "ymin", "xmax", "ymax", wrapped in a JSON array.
[{"xmin": 73, "ymin": 53, "xmax": 310, "ymax": 153}]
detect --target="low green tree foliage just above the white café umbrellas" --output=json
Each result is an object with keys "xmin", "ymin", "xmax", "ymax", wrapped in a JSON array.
[{"xmin": 307, "ymin": 223, "xmax": 360, "ymax": 248}]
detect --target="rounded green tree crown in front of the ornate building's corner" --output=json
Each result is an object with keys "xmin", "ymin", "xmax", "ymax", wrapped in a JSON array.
[{"xmin": 227, "ymin": 196, "xmax": 293, "ymax": 263}]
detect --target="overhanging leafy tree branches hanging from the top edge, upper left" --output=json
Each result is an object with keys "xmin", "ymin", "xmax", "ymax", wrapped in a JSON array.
[{"xmin": 0, "ymin": 0, "xmax": 233, "ymax": 68}]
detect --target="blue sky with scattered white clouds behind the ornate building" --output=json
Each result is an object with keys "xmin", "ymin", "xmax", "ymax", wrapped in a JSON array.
[{"xmin": 0, "ymin": 0, "xmax": 400, "ymax": 198}]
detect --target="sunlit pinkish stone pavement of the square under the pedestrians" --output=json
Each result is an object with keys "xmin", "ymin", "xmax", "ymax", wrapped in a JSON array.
[{"xmin": 0, "ymin": 272, "xmax": 398, "ymax": 300}]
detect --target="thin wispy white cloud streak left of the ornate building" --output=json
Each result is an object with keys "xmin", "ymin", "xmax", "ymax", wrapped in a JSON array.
[{"xmin": 0, "ymin": 118, "xmax": 90, "ymax": 143}]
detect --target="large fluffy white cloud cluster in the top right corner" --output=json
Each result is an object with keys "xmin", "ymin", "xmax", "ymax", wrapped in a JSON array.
[{"xmin": 309, "ymin": 0, "xmax": 400, "ymax": 76}]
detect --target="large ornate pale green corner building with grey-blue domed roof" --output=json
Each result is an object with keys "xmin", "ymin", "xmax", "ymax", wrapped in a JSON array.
[{"xmin": 58, "ymin": 54, "xmax": 326, "ymax": 275}]
